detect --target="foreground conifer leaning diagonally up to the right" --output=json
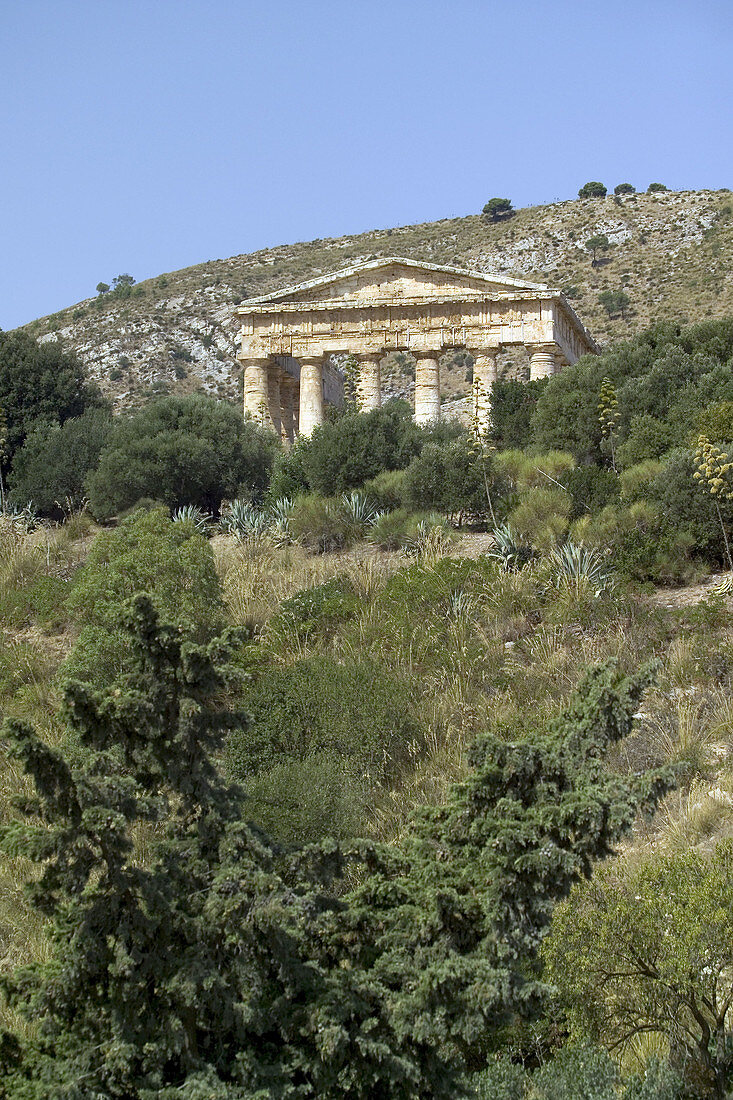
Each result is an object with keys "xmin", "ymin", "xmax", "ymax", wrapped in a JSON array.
[{"xmin": 305, "ymin": 664, "xmax": 671, "ymax": 1100}]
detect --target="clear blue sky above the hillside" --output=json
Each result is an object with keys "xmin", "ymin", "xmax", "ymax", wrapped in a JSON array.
[{"xmin": 0, "ymin": 0, "xmax": 733, "ymax": 329}]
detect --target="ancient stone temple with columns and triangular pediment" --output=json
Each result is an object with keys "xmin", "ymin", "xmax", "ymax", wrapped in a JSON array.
[{"xmin": 237, "ymin": 259, "xmax": 598, "ymax": 442}]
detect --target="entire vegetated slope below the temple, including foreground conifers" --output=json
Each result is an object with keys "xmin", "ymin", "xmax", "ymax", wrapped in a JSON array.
[{"xmin": 0, "ymin": 321, "xmax": 733, "ymax": 1100}]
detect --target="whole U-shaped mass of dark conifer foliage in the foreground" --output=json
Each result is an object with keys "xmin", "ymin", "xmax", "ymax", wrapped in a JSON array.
[{"xmin": 0, "ymin": 596, "xmax": 669, "ymax": 1100}]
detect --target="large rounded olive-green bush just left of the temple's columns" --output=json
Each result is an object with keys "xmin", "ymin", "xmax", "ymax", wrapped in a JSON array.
[{"xmin": 88, "ymin": 395, "xmax": 280, "ymax": 518}]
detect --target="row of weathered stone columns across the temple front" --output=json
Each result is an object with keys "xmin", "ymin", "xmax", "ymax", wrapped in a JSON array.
[{"xmin": 243, "ymin": 344, "xmax": 565, "ymax": 443}]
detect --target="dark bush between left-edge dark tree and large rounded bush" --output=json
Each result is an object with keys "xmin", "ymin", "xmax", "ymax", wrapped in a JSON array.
[{"xmin": 8, "ymin": 408, "xmax": 112, "ymax": 518}]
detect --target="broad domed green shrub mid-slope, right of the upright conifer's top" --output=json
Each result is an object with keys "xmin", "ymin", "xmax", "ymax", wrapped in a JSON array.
[{"xmin": 226, "ymin": 656, "xmax": 422, "ymax": 782}]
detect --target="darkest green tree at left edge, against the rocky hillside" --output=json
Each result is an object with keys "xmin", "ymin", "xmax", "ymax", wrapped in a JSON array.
[{"xmin": 0, "ymin": 331, "xmax": 102, "ymax": 464}]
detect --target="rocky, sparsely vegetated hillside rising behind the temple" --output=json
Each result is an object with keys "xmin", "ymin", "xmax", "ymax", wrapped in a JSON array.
[{"xmin": 19, "ymin": 189, "xmax": 733, "ymax": 407}]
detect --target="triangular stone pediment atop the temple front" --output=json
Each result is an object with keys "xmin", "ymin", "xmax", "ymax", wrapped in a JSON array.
[{"xmin": 240, "ymin": 257, "xmax": 553, "ymax": 308}]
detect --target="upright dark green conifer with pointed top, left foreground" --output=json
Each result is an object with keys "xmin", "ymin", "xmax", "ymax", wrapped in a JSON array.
[{"xmin": 0, "ymin": 596, "xmax": 338, "ymax": 1100}]
